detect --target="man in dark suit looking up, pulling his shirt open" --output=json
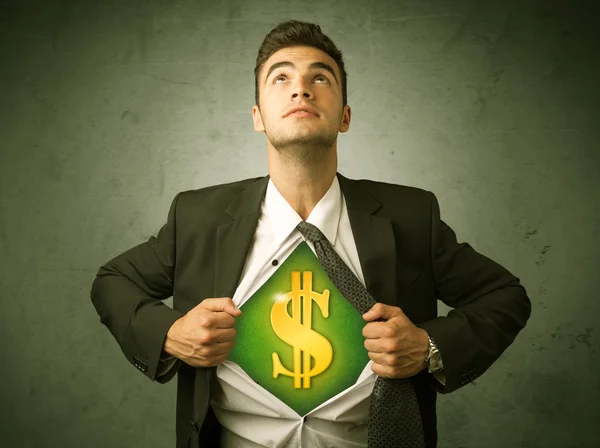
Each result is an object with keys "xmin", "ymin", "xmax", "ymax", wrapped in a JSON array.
[{"xmin": 91, "ymin": 21, "xmax": 531, "ymax": 448}]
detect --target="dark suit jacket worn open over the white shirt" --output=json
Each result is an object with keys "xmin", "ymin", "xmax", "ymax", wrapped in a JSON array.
[{"xmin": 91, "ymin": 173, "xmax": 531, "ymax": 448}]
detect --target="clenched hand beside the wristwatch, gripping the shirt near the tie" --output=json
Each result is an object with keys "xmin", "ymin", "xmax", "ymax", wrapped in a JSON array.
[{"xmin": 362, "ymin": 303, "xmax": 429, "ymax": 378}]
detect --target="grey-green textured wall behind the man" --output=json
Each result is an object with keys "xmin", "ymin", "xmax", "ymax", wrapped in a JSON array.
[{"xmin": 0, "ymin": 0, "xmax": 600, "ymax": 448}]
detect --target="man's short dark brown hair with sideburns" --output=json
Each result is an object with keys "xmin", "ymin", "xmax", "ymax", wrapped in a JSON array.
[{"xmin": 254, "ymin": 20, "xmax": 348, "ymax": 107}]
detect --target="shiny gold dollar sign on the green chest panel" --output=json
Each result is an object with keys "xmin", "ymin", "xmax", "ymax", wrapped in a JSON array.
[{"xmin": 271, "ymin": 271, "xmax": 333, "ymax": 389}]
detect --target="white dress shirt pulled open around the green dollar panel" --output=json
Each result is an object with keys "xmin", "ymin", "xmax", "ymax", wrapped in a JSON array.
[{"xmin": 210, "ymin": 176, "xmax": 377, "ymax": 448}]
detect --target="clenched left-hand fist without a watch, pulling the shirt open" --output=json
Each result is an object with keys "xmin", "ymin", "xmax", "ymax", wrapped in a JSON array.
[{"xmin": 163, "ymin": 297, "xmax": 242, "ymax": 367}]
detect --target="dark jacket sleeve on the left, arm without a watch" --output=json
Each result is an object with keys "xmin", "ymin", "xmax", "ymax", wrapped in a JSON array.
[{"xmin": 91, "ymin": 193, "xmax": 184, "ymax": 383}]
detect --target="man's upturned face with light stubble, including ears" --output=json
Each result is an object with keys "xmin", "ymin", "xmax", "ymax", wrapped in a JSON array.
[{"xmin": 252, "ymin": 47, "xmax": 350, "ymax": 158}]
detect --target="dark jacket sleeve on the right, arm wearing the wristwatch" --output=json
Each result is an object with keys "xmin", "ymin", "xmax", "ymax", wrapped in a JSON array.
[{"xmin": 418, "ymin": 192, "xmax": 531, "ymax": 393}]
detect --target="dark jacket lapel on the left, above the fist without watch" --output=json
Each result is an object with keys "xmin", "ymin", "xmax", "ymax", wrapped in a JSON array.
[{"xmin": 214, "ymin": 176, "xmax": 269, "ymax": 297}]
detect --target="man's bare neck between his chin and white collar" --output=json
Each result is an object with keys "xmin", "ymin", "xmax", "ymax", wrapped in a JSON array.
[{"xmin": 269, "ymin": 148, "xmax": 337, "ymax": 220}]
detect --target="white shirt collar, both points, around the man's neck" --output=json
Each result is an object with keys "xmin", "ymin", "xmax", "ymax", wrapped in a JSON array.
[{"xmin": 262, "ymin": 176, "xmax": 342, "ymax": 245}]
